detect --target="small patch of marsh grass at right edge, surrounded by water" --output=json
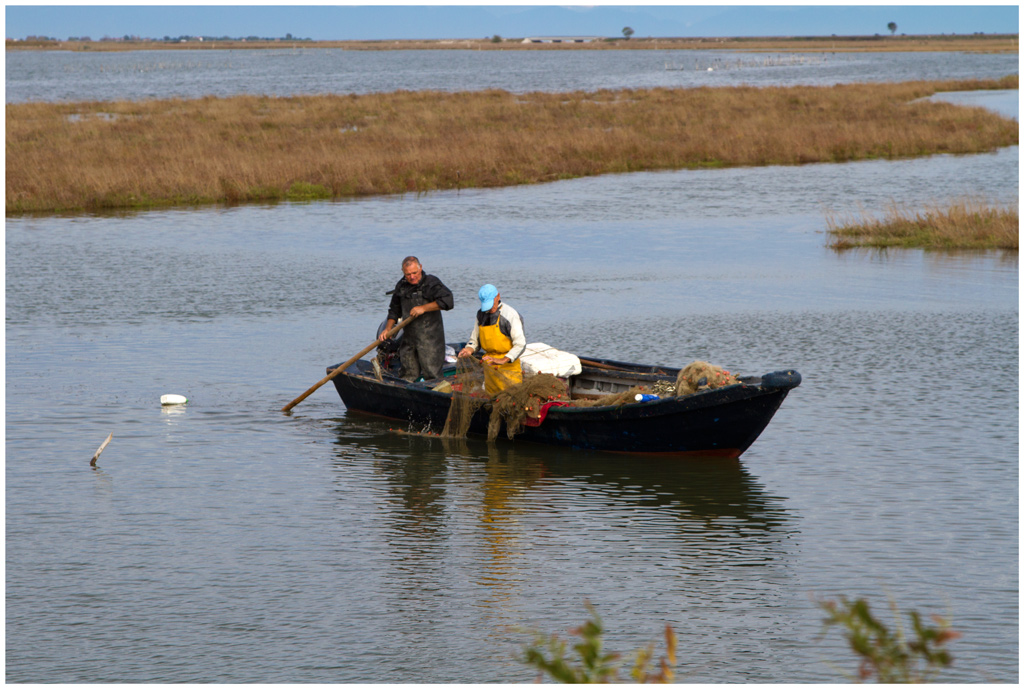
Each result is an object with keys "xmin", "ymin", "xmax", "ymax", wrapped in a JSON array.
[{"xmin": 826, "ymin": 199, "xmax": 1020, "ymax": 251}]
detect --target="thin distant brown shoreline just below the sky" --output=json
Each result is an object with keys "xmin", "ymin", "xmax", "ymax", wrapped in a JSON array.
[{"xmin": 7, "ymin": 34, "xmax": 1019, "ymax": 53}]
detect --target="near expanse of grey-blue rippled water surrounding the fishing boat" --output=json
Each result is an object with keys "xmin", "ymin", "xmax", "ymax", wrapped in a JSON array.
[{"xmin": 5, "ymin": 55, "xmax": 1019, "ymax": 683}]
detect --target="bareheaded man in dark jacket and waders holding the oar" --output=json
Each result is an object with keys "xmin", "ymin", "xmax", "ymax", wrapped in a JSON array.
[{"xmin": 379, "ymin": 256, "xmax": 455, "ymax": 381}]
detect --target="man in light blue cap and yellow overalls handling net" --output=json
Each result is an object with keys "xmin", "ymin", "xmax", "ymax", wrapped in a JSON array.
[{"xmin": 459, "ymin": 285, "xmax": 526, "ymax": 395}]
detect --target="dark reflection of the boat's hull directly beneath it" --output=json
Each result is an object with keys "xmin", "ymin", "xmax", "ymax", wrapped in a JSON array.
[{"xmin": 327, "ymin": 429, "xmax": 787, "ymax": 526}]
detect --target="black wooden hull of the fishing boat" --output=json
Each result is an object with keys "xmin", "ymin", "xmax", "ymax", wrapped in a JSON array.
[{"xmin": 328, "ymin": 349, "xmax": 801, "ymax": 458}]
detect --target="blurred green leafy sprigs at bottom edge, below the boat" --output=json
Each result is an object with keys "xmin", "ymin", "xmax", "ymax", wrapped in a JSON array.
[{"xmin": 522, "ymin": 603, "xmax": 676, "ymax": 684}]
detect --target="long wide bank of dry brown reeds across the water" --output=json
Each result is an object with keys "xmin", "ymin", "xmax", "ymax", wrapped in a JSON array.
[{"xmin": 6, "ymin": 76, "xmax": 1018, "ymax": 213}]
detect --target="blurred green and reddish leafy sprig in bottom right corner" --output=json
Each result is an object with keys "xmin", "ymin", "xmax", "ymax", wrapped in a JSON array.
[{"xmin": 818, "ymin": 598, "xmax": 961, "ymax": 684}]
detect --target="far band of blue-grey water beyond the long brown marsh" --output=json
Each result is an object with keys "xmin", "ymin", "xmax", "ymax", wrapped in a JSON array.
[{"xmin": 6, "ymin": 49, "xmax": 1020, "ymax": 102}]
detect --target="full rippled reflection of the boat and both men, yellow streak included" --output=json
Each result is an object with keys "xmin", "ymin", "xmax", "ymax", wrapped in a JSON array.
[{"xmin": 333, "ymin": 423, "xmax": 797, "ymax": 618}]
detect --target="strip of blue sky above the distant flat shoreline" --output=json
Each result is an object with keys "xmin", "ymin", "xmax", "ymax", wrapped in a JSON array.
[{"xmin": 5, "ymin": 4, "xmax": 1020, "ymax": 40}]
